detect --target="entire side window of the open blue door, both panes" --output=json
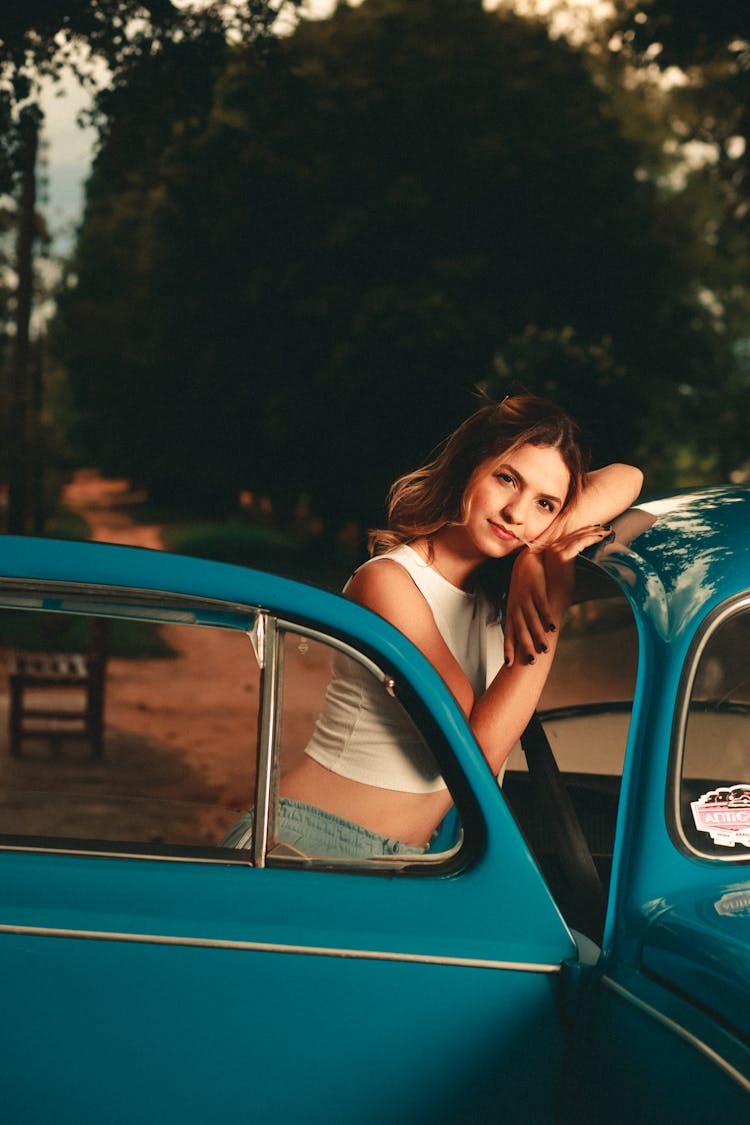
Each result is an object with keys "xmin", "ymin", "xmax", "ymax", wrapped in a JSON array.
[{"xmin": 0, "ymin": 597, "xmax": 461, "ymax": 869}]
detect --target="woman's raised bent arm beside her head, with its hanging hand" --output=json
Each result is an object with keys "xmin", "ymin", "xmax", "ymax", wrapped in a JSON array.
[{"xmin": 505, "ymin": 465, "xmax": 643, "ymax": 665}]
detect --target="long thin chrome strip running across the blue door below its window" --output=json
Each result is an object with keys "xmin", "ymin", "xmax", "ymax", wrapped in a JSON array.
[{"xmin": 0, "ymin": 923, "xmax": 562, "ymax": 974}]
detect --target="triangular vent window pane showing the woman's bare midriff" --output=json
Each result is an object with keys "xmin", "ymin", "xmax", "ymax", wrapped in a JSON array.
[{"xmin": 260, "ymin": 630, "xmax": 459, "ymax": 866}]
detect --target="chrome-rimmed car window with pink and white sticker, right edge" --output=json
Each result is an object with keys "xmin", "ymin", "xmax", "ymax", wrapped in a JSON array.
[{"xmin": 676, "ymin": 597, "xmax": 750, "ymax": 861}]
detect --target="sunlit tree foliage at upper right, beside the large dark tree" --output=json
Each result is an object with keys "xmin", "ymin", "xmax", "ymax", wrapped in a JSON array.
[{"xmin": 609, "ymin": 0, "xmax": 750, "ymax": 478}]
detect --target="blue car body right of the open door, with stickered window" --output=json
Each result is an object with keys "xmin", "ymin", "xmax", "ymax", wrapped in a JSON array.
[{"xmin": 568, "ymin": 515, "xmax": 750, "ymax": 1125}]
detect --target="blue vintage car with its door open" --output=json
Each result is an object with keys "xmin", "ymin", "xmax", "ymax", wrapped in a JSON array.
[{"xmin": 0, "ymin": 487, "xmax": 750, "ymax": 1125}]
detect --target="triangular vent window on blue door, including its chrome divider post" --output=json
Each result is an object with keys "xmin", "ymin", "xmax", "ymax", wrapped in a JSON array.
[{"xmin": 240, "ymin": 622, "xmax": 462, "ymax": 870}]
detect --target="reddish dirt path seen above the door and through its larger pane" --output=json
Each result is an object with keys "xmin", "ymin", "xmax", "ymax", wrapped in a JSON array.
[{"xmin": 0, "ymin": 473, "xmax": 266, "ymax": 844}]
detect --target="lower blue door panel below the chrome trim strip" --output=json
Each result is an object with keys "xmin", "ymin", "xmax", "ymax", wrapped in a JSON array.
[{"xmin": 2, "ymin": 935, "xmax": 562, "ymax": 1125}]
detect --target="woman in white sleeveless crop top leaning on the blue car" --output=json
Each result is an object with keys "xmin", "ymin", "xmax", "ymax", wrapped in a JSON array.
[{"xmin": 226, "ymin": 395, "xmax": 642, "ymax": 856}]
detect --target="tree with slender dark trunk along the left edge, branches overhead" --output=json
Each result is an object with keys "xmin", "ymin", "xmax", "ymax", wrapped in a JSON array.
[{"xmin": 0, "ymin": 0, "xmax": 299, "ymax": 532}]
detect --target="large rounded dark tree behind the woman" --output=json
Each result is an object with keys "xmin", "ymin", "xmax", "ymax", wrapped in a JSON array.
[{"xmin": 58, "ymin": 0, "xmax": 750, "ymax": 531}]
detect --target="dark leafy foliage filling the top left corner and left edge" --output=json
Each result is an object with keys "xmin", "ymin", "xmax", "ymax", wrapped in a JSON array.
[{"xmin": 0, "ymin": 0, "xmax": 298, "ymax": 533}]
